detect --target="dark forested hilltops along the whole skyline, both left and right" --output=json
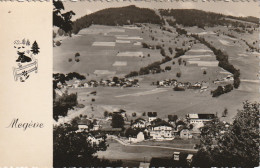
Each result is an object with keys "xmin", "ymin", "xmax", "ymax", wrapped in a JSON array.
[{"xmin": 72, "ymin": 5, "xmax": 259, "ymax": 34}]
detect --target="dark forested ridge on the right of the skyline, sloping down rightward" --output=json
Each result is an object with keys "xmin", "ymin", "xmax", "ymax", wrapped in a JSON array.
[{"xmin": 160, "ymin": 9, "xmax": 259, "ymax": 28}]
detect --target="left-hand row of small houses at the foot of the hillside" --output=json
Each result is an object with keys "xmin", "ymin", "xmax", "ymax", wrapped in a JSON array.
[{"xmin": 63, "ymin": 78, "xmax": 139, "ymax": 88}]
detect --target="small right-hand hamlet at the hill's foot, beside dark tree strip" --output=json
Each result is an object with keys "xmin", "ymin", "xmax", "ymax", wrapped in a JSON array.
[{"xmin": 157, "ymin": 79, "xmax": 209, "ymax": 90}]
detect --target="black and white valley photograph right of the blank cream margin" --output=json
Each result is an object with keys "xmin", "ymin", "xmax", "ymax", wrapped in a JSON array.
[{"xmin": 52, "ymin": 1, "xmax": 260, "ymax": 168}]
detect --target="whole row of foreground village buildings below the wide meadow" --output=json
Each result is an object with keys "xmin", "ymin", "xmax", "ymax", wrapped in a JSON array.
[{"xmin": 72, "ymin": 110, "xmax": 215, "ymax": 143}]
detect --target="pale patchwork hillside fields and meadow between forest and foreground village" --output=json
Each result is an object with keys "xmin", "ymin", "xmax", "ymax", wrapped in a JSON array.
[{"xmin": 54, "ymin": 24, "xmax": 259, "ymax": 121}]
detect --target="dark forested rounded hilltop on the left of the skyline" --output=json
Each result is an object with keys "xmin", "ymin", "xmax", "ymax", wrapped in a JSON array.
[{"xmin": 72, "ymin": 5, "xmax": 163, "ymax": 34}]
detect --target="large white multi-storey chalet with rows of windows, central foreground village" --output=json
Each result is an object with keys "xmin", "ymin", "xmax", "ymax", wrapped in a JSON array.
[{"xmin": 150, "ymin": 121, "xmax": 174, "ymax": 140}]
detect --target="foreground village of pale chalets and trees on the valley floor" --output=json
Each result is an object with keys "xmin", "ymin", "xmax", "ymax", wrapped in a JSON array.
[{"xmin": 70, "ymin": 109, "xmax": 215, "ymax": 144}]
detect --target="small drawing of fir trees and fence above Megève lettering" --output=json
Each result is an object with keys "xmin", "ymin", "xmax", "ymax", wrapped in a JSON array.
[{"xmin": 13, "ymin": 39, "xmax": 40, "ymax": 82}]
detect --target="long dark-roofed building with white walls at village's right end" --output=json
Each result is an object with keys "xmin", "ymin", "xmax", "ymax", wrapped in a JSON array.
[{"xmin": 186, "ymin": 114, "xmax": 215, "ymax": 124}]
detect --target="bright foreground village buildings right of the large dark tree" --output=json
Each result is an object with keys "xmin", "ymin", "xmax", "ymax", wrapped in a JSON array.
[{"xmin": 126, "ymin": 112, "xmax": 215, "ymax": 142}]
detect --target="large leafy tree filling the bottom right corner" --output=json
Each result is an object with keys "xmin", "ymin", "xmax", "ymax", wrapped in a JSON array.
[{"xmin": 192, "ymin": 101, "xmax": 260, "ymax": 167}]
